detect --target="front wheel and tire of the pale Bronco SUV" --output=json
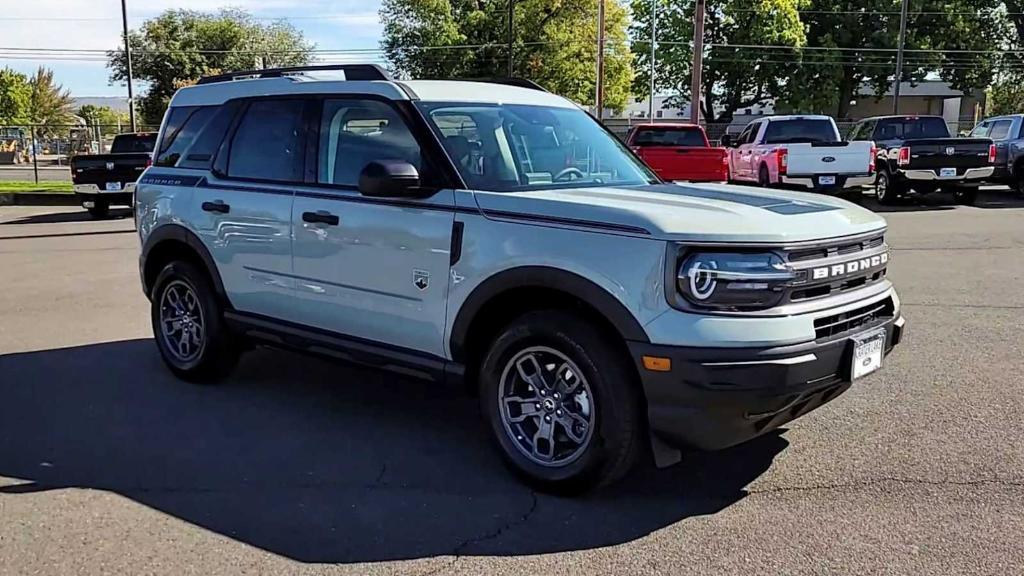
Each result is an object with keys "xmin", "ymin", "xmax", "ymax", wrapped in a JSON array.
[{"xmin": 479, "ymin": 311, "xmax": 643, "ymax": 494}]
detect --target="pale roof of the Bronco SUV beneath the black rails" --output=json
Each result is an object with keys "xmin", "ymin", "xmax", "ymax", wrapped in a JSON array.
[{"xmin": 165, "ymin": 76, "xmax": 578, "ymax": 108}]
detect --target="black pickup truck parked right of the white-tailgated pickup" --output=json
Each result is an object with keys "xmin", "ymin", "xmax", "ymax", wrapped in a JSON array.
[{"xmin": 849, "ymin": 116, "xmax": 995, "ymax": 204}]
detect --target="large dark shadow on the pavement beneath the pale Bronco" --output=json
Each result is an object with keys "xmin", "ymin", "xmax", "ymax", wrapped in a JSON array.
[{"xmin": 0, "ymin": 339, "xmax": 787, "ymax": 563}]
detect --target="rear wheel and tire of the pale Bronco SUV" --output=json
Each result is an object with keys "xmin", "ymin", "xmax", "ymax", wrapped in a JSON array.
[{"xmin": 150, "ymin": 260, "xmax": 240, "ymax": 383}]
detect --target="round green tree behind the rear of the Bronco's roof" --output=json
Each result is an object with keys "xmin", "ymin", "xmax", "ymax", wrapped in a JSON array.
[{"xmin": 108, "ymin": 9, "xmax": 313, "ymax": 124}]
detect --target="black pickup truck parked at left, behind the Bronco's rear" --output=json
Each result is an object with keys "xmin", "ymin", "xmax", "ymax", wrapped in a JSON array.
[{"xmin": 71, "ymin": 132, "xmax": 157, "ymax": 218}]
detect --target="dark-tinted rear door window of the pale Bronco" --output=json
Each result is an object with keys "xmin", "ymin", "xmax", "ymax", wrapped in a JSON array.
[{"xmin": 227, "ymin": 99, "xmax": 305, "ymax": 181}]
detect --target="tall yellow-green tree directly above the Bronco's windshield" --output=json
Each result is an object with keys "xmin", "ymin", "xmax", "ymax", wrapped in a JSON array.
[{"xmin": 380, "ymin": 0, "xmax": 633, "ymax": 110}]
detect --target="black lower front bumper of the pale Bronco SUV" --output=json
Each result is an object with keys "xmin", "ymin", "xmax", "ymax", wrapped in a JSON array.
[{"xmin": 629, "ymin": 314, "xmax": 904, "ymax": 450}]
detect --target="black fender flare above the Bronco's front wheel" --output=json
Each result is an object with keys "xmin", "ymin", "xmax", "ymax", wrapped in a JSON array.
[{"xmin": 450, "ymin": 266, "xmax": 650, "ymax": 362}]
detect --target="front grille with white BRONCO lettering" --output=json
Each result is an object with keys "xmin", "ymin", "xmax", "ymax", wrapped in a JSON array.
[{"xmin": 783, "ymin": 234, "xmax": 886, "ymax": 302}]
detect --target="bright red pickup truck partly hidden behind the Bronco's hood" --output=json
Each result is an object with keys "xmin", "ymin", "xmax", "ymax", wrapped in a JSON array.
[{"xmin": 626, "ymin": 124, "xmax": 729, "ymax": 182}]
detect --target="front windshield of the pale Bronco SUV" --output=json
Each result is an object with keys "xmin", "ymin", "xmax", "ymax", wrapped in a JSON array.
[{"xmin": 417, "ymin": 102, "xmax": 657, "ymax": 192}]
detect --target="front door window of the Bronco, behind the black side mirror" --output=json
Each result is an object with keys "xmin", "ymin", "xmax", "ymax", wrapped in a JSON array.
[{"xmin": 317, "ymin": 99, "xmax": 423, "ymax": 187}]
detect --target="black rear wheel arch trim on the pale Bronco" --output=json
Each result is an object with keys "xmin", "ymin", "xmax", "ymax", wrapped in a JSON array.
[{"xmin": 140, "ymin": 224, "xmax": 228, "ymax": 303}]
